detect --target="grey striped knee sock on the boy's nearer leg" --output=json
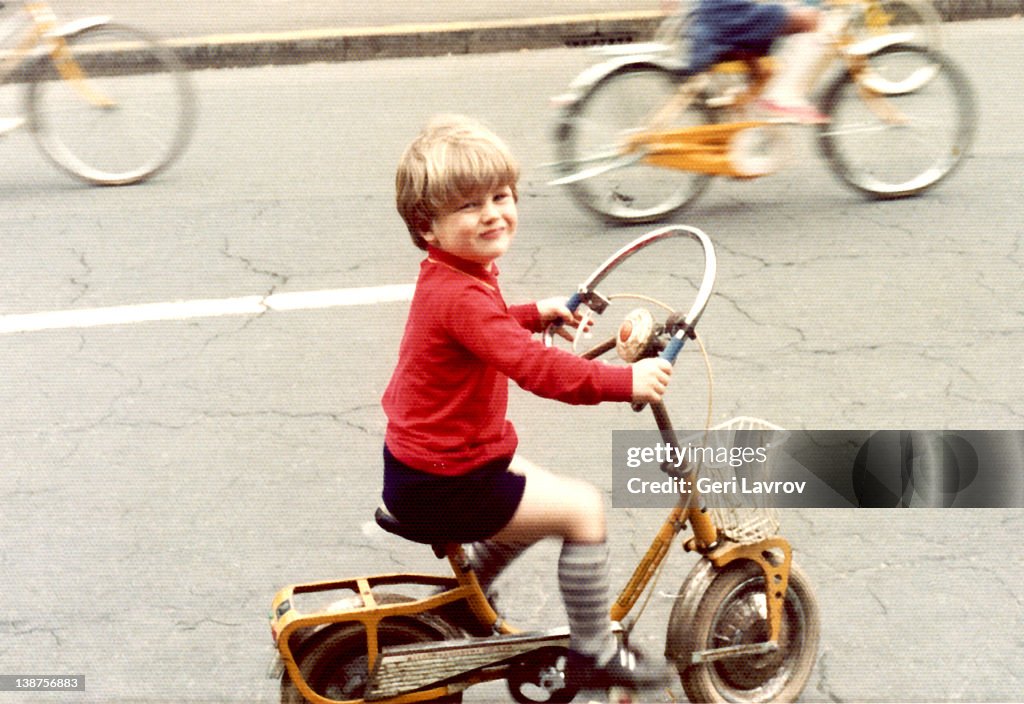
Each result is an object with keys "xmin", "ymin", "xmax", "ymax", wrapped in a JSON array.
[{"xmin": 558, "ymin": 542, "xmax": 615, "ymax": 662}]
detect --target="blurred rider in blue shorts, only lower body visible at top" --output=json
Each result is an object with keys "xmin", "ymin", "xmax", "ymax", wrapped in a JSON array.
[{"xmin": 690, "ymin": 0, "xmax": 829, "ymax": 124}]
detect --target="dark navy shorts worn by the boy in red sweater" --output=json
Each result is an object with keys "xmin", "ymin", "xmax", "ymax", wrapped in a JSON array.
[{"xmin": 383, "ymin": 446, "xmax": 526, "ymax": 542}]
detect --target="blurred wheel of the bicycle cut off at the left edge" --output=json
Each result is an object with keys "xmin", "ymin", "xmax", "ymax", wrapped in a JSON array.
[{"xmin": 27, "ymin": 24, "xmax": 196, "ymax": 185}]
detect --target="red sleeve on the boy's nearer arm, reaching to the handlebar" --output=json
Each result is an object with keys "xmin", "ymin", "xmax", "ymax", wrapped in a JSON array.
[{"xmin": 444, "ymin": 287, "xmax": 633, "ymax": 404}]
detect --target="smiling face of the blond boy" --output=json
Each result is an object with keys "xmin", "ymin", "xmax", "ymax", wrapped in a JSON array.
[{"xmin": 423, "ymin": 186, "xmax": 519, "ymax": 266}]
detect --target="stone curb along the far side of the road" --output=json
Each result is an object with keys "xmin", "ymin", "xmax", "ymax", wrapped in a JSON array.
[{"xmin": 161, "ymin": 0, "xmax": 1024, "ymax": 69}]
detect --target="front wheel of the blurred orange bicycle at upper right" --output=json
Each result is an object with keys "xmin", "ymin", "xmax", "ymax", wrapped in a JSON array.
[{"xmin": 818, "ymin": 44, "xmax": 977, "ymax": 199}]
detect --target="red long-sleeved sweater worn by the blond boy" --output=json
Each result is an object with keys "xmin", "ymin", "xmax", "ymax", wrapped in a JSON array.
[{"xmin": 383, "ymin": 248, "xmax": 633, "ymax": 475}]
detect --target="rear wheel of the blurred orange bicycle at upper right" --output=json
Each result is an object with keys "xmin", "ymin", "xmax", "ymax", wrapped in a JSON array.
[{"xmin": 556, "ymin": 63, "xmax": 715, "ymax": 224}]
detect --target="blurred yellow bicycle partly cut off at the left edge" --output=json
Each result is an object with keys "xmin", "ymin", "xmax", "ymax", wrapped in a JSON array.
[{"xmin": 0, "ymin": 0, "xmax": 196, "ymax": 185}]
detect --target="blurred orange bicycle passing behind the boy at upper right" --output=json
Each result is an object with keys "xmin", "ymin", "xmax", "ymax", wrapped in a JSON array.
[{"xmin": 550, "ymin": 4, "xmax": 977, "ymax": 223}]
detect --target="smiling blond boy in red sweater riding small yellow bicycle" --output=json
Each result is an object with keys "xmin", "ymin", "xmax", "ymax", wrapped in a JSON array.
[{"xmin": 383, "ymin": 112, "xmax": 672, "ymax": 689}]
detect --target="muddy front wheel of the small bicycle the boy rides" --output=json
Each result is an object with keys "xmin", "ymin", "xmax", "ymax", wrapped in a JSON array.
[{"xmin": 669, "ymin": 561, "xmax": 821, "ymax": 704}]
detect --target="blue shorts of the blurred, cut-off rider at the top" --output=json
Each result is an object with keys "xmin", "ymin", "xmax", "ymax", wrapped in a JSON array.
[{"xmin": 690, "ymin": 0, "xmax": 788, "ymax": 71}]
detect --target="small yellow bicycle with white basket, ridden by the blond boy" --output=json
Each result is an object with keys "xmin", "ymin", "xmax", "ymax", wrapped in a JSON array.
[{"xmin": 269, "ymin": 225, "xmax": 820, "ymax": 704}]
